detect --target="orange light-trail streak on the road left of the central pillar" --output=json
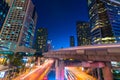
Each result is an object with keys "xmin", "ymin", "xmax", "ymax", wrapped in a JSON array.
[{"xmin": 13, "ymin": 59, "xmax": 54, "ymax": 80}]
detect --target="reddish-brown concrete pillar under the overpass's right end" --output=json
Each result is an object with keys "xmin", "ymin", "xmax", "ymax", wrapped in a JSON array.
[{"xmin": 102, "ymin": 62, "xmax": 113, "ymax": 80}]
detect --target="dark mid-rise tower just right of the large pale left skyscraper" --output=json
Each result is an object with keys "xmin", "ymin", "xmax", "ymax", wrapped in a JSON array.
[{"xmin": 36, "ymin": 27, "xmax": 48, "ymax": 54}]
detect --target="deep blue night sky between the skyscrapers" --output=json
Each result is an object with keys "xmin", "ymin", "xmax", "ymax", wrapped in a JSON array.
[{"xmin": 33, "ymin": 0, "xmax": 88, "ymax": 49}]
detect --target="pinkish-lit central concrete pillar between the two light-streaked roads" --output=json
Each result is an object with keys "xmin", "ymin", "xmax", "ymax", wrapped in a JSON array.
[{"xmin": 55, "ymin": 60, "xmax": 64, "ymax": 80}]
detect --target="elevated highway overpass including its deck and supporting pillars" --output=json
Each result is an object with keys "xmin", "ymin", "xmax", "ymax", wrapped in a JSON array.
[{"xmin": 43, "ymin": 44, "xmax": 120, "ymax": 80}]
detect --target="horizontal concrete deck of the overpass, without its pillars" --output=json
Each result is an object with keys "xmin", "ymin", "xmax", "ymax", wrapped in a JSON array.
[{"xmin": 43, "ymin": 44, "xmax": 120, "ymax": 61}]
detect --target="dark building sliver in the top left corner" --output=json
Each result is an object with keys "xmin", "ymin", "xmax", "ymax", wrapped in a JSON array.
[{"xmin": 0, "ymin": 0, "xmax": 9, "ymax": 31}]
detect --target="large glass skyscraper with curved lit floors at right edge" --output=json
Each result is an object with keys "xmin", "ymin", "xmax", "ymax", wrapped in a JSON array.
[{"xmin": 88, "ymin": 0, "xmax": 120, "ymax": 44}]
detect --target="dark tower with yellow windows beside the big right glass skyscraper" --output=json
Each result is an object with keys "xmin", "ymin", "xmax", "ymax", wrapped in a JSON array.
[{"xmin": 76, "ymin": 21, "xmax": 91, "ymax": 46}]
